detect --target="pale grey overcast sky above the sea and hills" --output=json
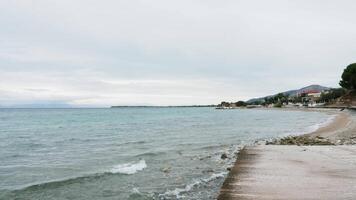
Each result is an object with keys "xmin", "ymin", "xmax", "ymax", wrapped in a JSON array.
[{"xmin": 0, "ymin": 0, "xmax": 356, "ymax": 107}]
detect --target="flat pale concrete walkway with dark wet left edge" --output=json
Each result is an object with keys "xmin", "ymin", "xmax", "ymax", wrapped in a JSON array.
[{"xmin": 218, "ymin": 145, "xmax": 356, "ymax": 200}]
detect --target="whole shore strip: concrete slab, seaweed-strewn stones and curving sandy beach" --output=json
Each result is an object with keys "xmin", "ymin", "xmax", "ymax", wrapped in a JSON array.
[{"xmin": 218, "ymin": 109, "xmax": 356, "ymax": 200}]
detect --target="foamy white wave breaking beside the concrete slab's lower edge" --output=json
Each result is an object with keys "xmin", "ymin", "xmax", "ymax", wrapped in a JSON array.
[{"xmin": 159, "ymin": 172, "xmax": 227, "ymax": 199}]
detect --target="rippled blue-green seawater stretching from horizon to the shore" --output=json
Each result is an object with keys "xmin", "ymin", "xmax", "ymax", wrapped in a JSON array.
[{"xmin": 0, "ymin": 108, "xmax": 332, "ymax": 200}]
